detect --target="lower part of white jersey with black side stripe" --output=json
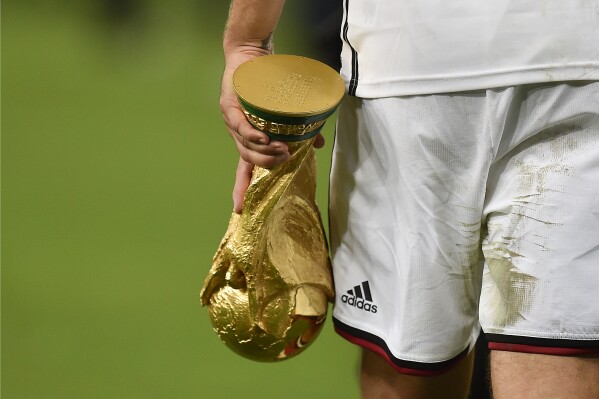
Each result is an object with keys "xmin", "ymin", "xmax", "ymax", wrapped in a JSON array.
[{"xmin": 341, "ymin": 0, "xmax": 599, "ymax": 98}]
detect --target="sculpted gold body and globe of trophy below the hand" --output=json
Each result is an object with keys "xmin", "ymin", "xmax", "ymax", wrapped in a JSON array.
[{"xmin": 200, "ymin": 139, "xmax": 334, "ymax": 361}]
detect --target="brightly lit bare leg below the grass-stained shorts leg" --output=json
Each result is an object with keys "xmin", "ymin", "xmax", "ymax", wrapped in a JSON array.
[{"xmin": 491, "ymin": 351, "xmax": 599, "ymax": 399}]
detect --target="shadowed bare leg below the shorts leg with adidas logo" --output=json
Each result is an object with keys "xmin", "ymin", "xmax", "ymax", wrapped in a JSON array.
[{"xmin": 360, "ymin": 350, "xmax": 474, "ymax": 399}]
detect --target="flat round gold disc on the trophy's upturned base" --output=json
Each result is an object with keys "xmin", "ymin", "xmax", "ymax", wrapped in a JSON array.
[{"xmin": 233, "ymin": 54, "xmax": 345, "ymax": 116}]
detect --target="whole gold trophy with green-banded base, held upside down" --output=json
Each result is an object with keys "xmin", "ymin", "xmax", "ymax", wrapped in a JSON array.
[{"xmin": 200, "ymin": 55, "xmax": 345, "ymax": 362}]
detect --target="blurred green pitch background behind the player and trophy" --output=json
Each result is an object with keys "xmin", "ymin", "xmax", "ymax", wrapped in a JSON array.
[{"xmin": 1, "ymin": 0, "xmax": 358, "ymax": 399}]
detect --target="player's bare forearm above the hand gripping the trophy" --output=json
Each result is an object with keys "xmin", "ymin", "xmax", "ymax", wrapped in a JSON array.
[{"xmin": 223, "ymin": 0, "xmax": 285, "ymax": 55}]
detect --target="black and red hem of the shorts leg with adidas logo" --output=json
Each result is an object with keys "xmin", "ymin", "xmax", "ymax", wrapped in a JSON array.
[{"xmin": 333, "ymin": 317, "xmax": 469, "ymax": 377}]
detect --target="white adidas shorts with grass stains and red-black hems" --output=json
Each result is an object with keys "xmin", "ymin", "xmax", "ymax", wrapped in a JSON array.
[{"xmin": 329, "ymin": 82, "xmax": 599, "ymax": 375}]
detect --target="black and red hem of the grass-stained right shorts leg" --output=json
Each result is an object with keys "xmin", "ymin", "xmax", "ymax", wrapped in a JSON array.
[{"xmin": 485, "ymin": 334, "xmax": 599, "ymax": 356}]
